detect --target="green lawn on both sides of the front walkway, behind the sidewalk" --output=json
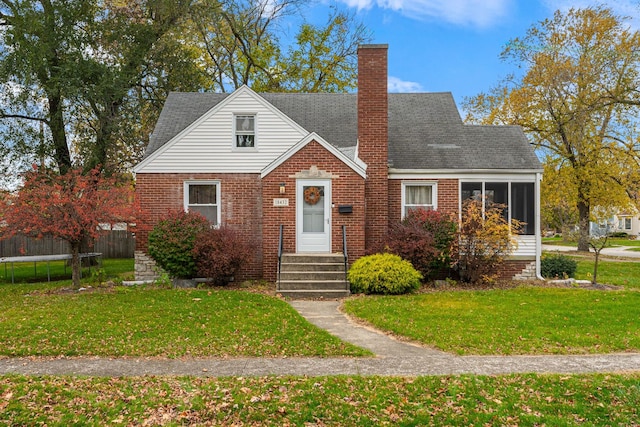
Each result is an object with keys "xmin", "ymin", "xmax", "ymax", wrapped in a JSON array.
[{"xmin": 0, "ymin": 258, "xmax": 640, "ymax": 357}]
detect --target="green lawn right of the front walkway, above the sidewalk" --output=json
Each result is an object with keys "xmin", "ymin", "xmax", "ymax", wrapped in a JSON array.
[{"xmin": 344, "ymin": 288, "xmax": 640, "ymax": 354}]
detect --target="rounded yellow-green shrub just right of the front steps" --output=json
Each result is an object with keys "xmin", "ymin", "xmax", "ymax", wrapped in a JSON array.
[{"xmin": 348, "ymin": 253, "xmax": 422, "ymax": 295}]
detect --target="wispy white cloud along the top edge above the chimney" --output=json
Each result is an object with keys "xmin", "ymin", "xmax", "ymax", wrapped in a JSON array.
[{"xmin": 341, "ymin": 0, "xmax": 512, "ymax": 27}]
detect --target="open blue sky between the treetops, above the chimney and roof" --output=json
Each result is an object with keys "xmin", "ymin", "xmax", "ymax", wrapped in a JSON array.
[{"xmin": 308, "ymin": 0, "xmax": 640, "ymax": 105}]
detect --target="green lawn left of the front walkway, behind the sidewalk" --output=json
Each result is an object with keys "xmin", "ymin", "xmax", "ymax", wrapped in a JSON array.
[{"xmin": 0, "ymin": 260, "xmax": 370, "ymax": 358}]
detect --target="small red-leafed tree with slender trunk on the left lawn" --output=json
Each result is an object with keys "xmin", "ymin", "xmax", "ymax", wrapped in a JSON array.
[{"xmin": 0, "ymin": 166, "xmax": 145, "ymax": 287}]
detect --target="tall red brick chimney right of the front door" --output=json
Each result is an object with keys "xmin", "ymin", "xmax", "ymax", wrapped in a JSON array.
[{"xmin": 358, "ymin": 44, "xmax": 389, "ymax": 249}]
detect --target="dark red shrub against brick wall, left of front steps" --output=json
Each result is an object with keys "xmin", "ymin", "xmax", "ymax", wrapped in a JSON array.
[{"xmin": 193, "ymin": 226, "xmax": 253, "ymax": 285}]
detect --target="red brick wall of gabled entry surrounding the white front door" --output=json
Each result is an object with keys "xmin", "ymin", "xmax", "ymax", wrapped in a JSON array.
[{"xmin": 262, "ymin": 141, "xmax": 365, "ymax": 281}]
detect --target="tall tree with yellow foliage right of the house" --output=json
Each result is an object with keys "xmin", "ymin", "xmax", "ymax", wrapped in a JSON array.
[{"xmin": 466, "ymin": 7, "xmax": 640, "ymax": 251}]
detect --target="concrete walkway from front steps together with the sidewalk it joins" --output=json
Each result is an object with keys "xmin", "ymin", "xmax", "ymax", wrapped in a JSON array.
[{"xmin": 0, "ymin": 301, "xmax": 640, "ymax": 377}]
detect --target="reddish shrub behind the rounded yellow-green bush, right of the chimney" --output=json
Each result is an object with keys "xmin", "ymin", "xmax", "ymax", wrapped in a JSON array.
[{"xmin": 377, "ymin": 209, "xmax": 457, "ymax": 280}]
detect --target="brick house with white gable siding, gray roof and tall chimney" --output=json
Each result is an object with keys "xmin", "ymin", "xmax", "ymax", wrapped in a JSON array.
[{"xmin": 134, "ymin": 45, "xmax": 542, "ymax": 294}]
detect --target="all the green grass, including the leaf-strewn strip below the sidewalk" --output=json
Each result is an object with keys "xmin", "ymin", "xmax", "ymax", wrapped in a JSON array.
[{"xmin": 0, "ymin": 260, "xmax": 640, "ymax": 426}]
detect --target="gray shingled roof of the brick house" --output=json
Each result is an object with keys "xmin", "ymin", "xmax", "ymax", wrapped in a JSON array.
[{"xmin": 145, "ymin": 92, "xmax": 541, "ymax": 170}]
